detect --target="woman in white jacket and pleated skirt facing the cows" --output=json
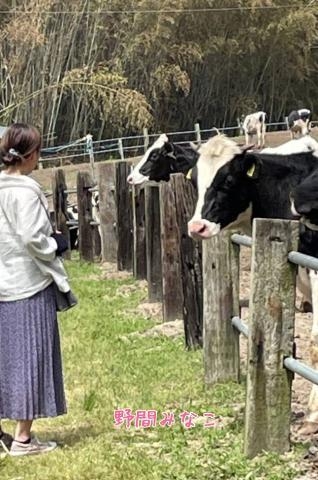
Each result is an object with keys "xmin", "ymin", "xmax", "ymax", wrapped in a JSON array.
[{"xmin": 0, "ymin": 123, "xmax": 70, "ymax": 456}]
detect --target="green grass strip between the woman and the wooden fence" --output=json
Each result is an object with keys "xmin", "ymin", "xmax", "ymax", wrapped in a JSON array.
[{"xmin": 0, "ymin": 261, "xmax": 308, "ymax": 480}]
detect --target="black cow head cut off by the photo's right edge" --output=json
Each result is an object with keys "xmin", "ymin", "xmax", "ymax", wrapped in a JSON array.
[{"xmin": 291, "ymin": 169, "xmax": 318, "ymax": 227}]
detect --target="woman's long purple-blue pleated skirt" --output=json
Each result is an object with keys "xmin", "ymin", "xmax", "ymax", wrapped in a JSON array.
[{"xmin": 0, "ymin": 285, "xmax": 66, "ymax": 420}]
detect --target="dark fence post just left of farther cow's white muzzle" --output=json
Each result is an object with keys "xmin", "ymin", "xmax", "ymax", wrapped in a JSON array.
[{"xmin": 115, "ymin": 162, "xmax": 133, "ymax": 270}]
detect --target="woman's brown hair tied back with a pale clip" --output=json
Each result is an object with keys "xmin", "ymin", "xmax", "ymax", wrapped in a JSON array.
[{"xmin": 0, "ymin": 123, "xmax": 42, "ymax": 166}]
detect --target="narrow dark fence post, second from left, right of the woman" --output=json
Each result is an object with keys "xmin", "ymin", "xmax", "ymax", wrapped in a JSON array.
[{"xmin": 77, "ymin": 172, "xmax": 94, "ymax": 262}]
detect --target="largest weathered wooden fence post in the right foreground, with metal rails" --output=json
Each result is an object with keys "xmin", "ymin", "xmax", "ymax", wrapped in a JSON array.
[{"xmin": 244, "ymin": 219, "xmax": 299, "ymax": 458}]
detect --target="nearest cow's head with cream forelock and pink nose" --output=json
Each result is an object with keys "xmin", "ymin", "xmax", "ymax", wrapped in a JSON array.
[{"xmin": 188, "ymin": 136, "xmax": 258, "ymax": 239}]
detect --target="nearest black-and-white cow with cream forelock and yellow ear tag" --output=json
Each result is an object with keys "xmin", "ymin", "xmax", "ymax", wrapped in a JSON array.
[{"xmin": 188, "ymin": 136, "xmax": 318, "ymax": 429}]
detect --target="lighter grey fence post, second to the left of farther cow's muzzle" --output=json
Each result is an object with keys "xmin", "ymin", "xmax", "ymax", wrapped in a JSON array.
[{"xmin": 97, "ymin": 163, "xmax": 118, "ymax": 263}]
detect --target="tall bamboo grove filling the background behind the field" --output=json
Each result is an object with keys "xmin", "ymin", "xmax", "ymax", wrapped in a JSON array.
[{"xmin": 0, "ymin": 0, "xmax": 318, "ymax": 141}]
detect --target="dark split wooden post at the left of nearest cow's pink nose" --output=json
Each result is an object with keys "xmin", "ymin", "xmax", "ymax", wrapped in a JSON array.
[{"xmin": 170, "ymin": 174, "xmax": 203, "ymax": 348}]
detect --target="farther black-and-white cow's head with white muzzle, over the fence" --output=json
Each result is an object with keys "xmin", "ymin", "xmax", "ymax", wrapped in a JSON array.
[{"xmin": 127, "ymin": 134, "xmax": 199, "ymax": 185}]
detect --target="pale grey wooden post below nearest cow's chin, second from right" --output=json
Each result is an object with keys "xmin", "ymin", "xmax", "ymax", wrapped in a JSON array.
[{"xmin": 203, "ymin": 231, "xmax": 239, "ymax": 385}]
